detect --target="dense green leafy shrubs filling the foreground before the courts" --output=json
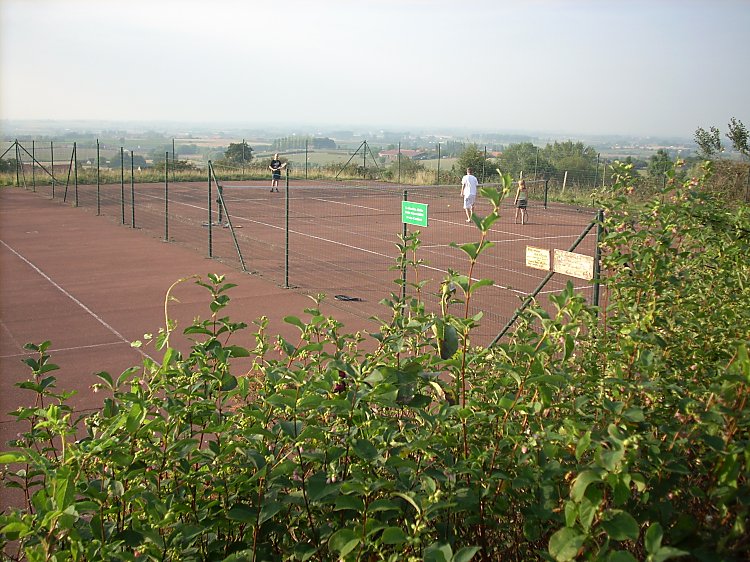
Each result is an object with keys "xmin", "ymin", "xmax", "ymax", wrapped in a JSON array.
[{"xmin": 0, "ymin": 161, "xmax": 750, "ymax": 562}]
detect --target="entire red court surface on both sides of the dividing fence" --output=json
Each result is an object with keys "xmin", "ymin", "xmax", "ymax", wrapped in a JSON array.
[{"xmin": 0, "ymin": 182, "xmax": 594, "ymax": 494}]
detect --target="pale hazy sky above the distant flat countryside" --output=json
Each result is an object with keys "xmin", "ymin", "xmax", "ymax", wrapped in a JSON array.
[{"xmin": 0, "ymin": 0, "xmax": 750, "ymax": 137}]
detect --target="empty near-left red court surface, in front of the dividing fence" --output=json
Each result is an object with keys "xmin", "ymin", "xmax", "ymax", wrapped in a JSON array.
[{"xmin": 0, "ymin": 188, "xmax": 374, "ymax": 505}]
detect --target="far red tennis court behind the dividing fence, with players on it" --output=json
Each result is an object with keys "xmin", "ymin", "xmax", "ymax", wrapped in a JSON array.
[{"xmin": 19, "ymin": 172, "xmax": 596, "ymax": 344}]
